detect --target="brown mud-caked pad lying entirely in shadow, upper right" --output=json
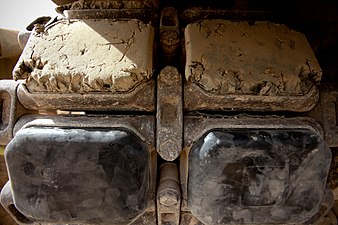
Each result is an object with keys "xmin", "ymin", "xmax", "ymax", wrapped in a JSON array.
[{"xmin": 185, "ymin": 20, "xmax": 322, "ymax": 96}]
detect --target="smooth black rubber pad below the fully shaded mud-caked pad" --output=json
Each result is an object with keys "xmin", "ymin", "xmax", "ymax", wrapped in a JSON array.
[{"xmin": 188, "ymin": 129, "xmax": 331, "ymax": 224}]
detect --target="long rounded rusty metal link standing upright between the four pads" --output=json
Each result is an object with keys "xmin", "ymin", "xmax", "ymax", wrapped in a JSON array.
[{"xmin": 156, "ymin": 66, "xmax": 183, "ymax": 161}]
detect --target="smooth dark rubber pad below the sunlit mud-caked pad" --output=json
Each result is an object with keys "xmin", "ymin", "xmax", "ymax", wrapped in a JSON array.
[{"xmin": 6, "ymin": 128, "xmax": 149, "ymax": 224}]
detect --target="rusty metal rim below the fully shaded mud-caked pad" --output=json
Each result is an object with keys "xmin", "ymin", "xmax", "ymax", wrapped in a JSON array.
[{"xmin": 184, "ymin": 83, "xmax": 319, "ymax": 112}]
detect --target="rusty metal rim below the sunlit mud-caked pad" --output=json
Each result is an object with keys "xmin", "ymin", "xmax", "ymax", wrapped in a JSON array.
[{"xmin": 17, "ymin": 80, "xmax": 155, "ymax": 112}]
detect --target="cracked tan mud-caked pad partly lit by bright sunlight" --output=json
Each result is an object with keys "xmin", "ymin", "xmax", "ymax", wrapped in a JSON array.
[{"xmin": 13, "ymin": 19, "xmax": 154, "ymax": 93}]
